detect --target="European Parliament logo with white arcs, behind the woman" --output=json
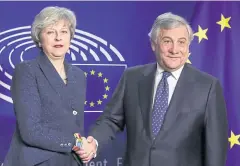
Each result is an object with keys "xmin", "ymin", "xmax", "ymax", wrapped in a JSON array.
[{"xmin": 0, "ymin": 26, "xmax": 127, "ymax": 112}]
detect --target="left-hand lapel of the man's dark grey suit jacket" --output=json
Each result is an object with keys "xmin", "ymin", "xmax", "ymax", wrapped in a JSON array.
[{"xmin": 138, "ymin": 64, "xmax": 157, "ymax": 138}]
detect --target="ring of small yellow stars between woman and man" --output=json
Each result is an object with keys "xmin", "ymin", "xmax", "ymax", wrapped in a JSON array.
[{"xmin": 84, "ymin": 70, "xmax": 110, "ymax": 107}]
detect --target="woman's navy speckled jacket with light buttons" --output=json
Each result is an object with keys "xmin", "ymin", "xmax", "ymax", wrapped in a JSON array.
[{"xmin": 4, "ymin": 54, "xmax": 86, "ymax": 166}]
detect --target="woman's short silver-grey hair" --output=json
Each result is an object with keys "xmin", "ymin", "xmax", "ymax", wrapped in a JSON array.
[{"xmin": 31, "ymin": 6, "xmax": 77, "ymax": 47}]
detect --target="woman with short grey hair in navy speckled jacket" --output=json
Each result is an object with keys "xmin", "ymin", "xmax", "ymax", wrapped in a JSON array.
[{"xmin": 4, "ymin": 7, "xmax": 86, "ymax": 166}]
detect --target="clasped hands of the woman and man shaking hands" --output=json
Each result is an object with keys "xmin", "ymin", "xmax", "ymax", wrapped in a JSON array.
[{"xmin": 72, "ymin": 133, "xmax": 98, "ymax": 163}]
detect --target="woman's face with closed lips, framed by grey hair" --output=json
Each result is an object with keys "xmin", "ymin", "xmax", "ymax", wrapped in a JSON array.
[{"xmin": 40, "ymin": 20, "xmax": 71, "ymax": 60}]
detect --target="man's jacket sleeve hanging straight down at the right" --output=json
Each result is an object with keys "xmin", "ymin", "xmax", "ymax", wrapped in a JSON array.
[{"xmin": 204, "ymin": 80, "xmax": 228, "ymax": 166}]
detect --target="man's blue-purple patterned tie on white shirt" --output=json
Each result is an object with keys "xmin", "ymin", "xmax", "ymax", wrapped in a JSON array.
[{"xmin": 152, "ymin": 71, "xmax": 171, "ymax": 138}]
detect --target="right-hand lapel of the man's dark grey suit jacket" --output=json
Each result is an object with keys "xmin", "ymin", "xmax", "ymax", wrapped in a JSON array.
[{"xmin": 155, "ymin": 64, "xmax": 194, "ymax": 137}]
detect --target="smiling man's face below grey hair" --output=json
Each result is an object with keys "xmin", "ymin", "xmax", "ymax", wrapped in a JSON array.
[{"xmin": 152, "ymin": 25, "xmax": 189, "ymax": 71}]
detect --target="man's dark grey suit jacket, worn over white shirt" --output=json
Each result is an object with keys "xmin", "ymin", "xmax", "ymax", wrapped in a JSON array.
[{"xmin": 89, "ymin": 64, "xmax": 228, "ymax": 166}]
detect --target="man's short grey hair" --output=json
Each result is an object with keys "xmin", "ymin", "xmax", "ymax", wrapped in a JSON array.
[{"xmin": 148, "ymin": 12, "xmax": 193, "ymax": 43}]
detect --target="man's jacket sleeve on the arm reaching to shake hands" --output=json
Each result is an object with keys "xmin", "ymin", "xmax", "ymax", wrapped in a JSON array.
[{"xmin": 89, "ymin": 72, "xmax": 126, "ymax": 154}]
